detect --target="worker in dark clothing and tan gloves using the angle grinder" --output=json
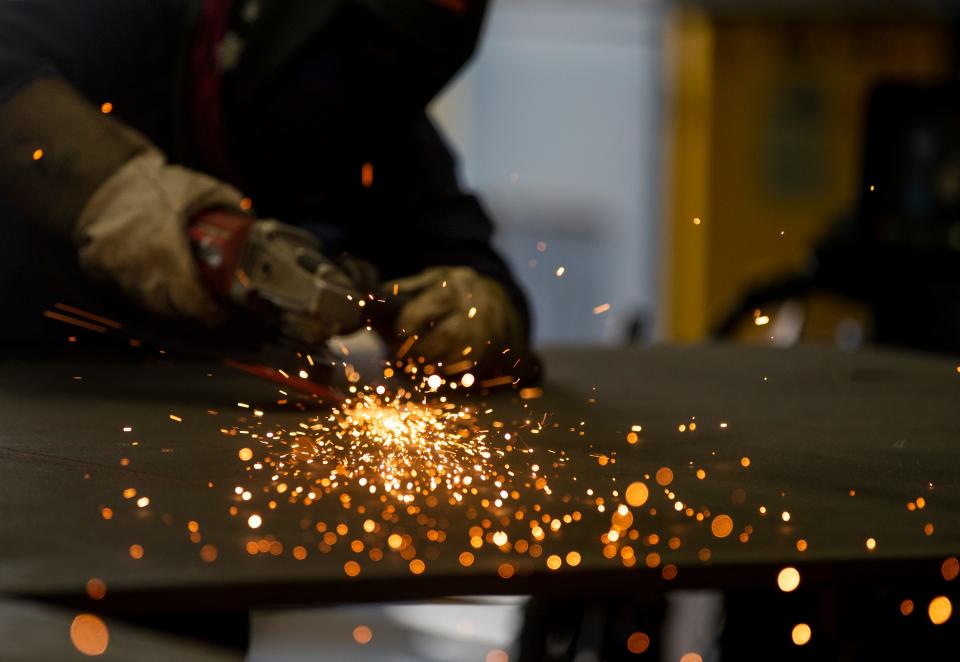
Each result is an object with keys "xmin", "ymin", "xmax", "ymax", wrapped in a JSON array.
[{"xmin": 0, "ymin": 0, "xmax": 529, "ymax": 376}]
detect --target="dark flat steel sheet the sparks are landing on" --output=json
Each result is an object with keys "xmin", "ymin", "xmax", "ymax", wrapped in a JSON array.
[{"xmin": 0, "ymin": 346, "xmax": 960, "ymax": 611}]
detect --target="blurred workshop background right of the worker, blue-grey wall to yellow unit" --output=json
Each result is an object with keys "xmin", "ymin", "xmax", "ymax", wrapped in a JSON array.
[{"xmin": 433, "ymin": 0, "xmax": 960, "ymax": 352}]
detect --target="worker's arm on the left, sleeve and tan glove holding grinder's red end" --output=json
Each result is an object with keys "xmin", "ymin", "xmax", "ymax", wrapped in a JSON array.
[{"xmin": 0, "ymin": 0, "xmax": 241, "ymax": 322}]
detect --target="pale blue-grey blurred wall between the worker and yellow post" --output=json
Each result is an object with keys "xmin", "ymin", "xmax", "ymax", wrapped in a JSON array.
[{"xmin": 433, "ymin": 0, "xmax": 669, "ymax": 343}]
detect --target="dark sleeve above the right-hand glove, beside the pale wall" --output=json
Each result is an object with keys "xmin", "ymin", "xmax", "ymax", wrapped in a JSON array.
[{"xmin": 366, "ymin": 115, "xmax": 530, "ymax": 332}]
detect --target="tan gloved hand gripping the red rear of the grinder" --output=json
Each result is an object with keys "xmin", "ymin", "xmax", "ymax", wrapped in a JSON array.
[{"xmin": 74, "ymin": 149, "xmax": 248, "ymax": 324}]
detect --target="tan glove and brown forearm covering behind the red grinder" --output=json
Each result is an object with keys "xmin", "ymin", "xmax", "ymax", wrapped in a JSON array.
[{"xmin": 0, "ymin": 76, "xmax": 241, "ymax": 323}]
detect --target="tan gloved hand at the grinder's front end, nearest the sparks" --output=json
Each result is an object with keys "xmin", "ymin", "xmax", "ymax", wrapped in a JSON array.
[{"xmin": 385, "ymin": 267, "xmax": 526, "ymax": 365}]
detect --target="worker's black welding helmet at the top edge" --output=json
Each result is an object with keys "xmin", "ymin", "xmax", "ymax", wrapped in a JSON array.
[{"xmin": 224, "ymin": 0, "xmax": 486, "ymax": 192}]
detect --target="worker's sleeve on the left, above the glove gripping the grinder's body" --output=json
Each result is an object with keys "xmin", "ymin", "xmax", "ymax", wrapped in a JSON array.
[{"xmin": 0, "ymin": 0, "xmax": 176, "ymax": 236}]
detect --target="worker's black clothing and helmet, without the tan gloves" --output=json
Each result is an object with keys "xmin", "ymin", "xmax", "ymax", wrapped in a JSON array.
[{"xmin": 0, "ymin": 0, "xmax": 526, "ymax": 348}]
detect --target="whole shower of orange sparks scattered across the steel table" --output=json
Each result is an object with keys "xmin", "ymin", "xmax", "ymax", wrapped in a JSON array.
[{"xmin": 77, "ymin": 320, "xmax": 960, "ymax": 659}]
